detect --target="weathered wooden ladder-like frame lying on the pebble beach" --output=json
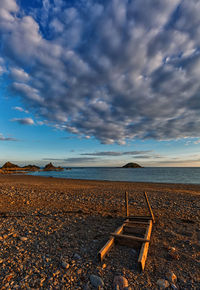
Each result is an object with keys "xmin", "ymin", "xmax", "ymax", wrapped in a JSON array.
[{"xmin": 98, "ymin": 192, "xmax": 155, "ymax": 271}]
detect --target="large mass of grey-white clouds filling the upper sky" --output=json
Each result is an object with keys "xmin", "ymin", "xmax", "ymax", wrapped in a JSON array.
[{"xmin": 0, "ymin": 0, "xmax": 200, "ymax": 144}]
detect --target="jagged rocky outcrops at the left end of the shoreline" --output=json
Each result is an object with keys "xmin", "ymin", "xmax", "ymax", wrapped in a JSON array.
[{"xmin": 0, "ymin": 161, "xmax": 64, "ymax": 174}]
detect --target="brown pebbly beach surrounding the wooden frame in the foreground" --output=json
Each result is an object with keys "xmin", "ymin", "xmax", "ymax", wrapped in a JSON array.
[{"xmin": 0, "ymin": 175, "xmax": 200, "ymax": 290}]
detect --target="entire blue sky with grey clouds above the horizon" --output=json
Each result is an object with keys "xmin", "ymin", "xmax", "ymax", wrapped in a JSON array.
[{"xmin": 0, "ymin": 0, "xmax": 200, "ymax": 167}]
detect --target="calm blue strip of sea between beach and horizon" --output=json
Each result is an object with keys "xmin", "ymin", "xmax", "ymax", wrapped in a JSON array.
[{"xmin": 30, "ymin": 167, "xmax": 200, "ymax": 184}]
